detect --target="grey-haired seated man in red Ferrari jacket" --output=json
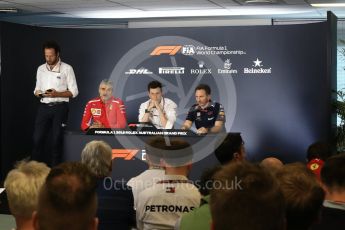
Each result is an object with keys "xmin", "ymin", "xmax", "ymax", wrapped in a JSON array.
[{"xmin": 81, "ymin": 79, "xmax": 127, "ymax": 131}]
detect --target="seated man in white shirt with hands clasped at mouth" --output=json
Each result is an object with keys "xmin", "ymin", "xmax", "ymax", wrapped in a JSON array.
[{"xmin": 138, "ymin": 81, "xmax": 177, "ymax": 129}]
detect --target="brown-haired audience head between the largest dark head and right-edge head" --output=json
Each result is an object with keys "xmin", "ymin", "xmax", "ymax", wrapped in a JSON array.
[{"xmin": 276, "ymin": 163, "xmax": 324, "ymax": 230}]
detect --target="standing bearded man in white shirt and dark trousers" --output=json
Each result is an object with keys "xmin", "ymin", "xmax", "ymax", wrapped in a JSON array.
[{"xmin": 32, "ymin": 41, "xmax": 78, "ymax": 166}]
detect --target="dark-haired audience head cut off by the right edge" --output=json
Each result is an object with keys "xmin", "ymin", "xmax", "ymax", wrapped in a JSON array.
[{"xmin": 321, "ymin": 153, "xmax": 345, "ymax": 199}]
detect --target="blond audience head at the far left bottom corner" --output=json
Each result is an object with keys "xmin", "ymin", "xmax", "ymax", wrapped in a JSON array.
[{"xmin": 4, "ymin": 161, "xmax": 50, "ymax": 230}]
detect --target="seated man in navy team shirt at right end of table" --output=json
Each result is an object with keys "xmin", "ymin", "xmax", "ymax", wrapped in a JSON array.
[{"xmin": 181, "ymin": 84, "xmax": 225, "ymax": 134}]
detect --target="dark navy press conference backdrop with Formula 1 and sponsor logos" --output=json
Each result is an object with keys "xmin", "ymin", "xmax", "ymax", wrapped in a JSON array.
[{"xmin": 1, "ymin": 23, "xmax": 330, "ymax": 180}]
